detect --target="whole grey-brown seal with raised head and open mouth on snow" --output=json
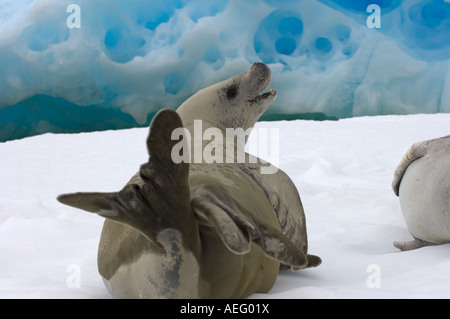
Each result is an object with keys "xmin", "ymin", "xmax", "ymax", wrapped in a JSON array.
[{"xmin": 58, "ymin": 64, "xmax": 321, "ymax": 298}]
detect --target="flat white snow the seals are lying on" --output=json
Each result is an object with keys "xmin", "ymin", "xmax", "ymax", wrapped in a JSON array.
[{"xmin": 0, "ymin": 114, "xmax": 450, "ymax": 298}]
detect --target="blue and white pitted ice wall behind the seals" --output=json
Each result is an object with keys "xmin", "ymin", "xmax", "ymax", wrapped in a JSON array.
[{"xmin": 0, "ymin": 0, "xmax": 450, "ymax": 141}]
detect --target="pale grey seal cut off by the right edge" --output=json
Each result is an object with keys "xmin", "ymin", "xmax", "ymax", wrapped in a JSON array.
[{"xmin": 392, "ymin": 135, "xmax": 450, "ymax": 250}]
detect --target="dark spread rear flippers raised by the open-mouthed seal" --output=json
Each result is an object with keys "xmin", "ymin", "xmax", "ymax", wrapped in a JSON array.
[{"xmin": 58, "ymin": 109, "xmax": 195, "ymax": 246}]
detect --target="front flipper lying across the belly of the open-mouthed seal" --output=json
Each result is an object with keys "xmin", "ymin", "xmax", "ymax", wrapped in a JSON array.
[{"xmin": 191, "ymin": 181, "xmax": 308, "ymax": 269}]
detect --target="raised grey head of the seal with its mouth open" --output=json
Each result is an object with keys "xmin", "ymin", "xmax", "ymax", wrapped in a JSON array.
[{"xmin": 177, "ymin": 63, "xmax": 277, "ymax": 130}]
